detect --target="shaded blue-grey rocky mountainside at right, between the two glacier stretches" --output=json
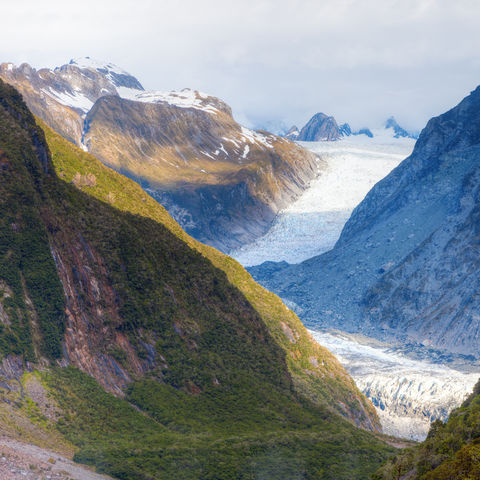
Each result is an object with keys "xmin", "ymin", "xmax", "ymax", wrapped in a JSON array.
[{"xmin": 251, "ymin": 84, "xmax": 480, "ymax": 357}]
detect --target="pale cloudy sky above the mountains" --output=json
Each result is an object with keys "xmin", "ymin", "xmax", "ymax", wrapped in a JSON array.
[{"xmin": 0, "ymin": 0, "xmax": 480, "ymax": 131}]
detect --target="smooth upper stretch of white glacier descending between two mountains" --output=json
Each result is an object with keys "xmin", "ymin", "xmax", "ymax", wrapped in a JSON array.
[{"xmin": 229, "ymin": 129, "xmax": 415, "ymax": 267}]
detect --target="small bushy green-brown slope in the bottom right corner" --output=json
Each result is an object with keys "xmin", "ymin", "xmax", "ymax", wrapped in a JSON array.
[{"xmin": 374, "ymin": 381, "xmax": 480, "ymax": 480}]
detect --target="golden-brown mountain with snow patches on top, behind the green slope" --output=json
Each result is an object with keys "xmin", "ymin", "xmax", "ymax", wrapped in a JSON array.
[{"xmin": 0, "ymin": 57, "xmax": 319, "ymax": 251}]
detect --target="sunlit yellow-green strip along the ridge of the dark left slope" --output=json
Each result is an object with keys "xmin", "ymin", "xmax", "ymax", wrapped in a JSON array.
[{"xmin": 42, "ymin": 120, "xmax": 379, "ymax": 429}]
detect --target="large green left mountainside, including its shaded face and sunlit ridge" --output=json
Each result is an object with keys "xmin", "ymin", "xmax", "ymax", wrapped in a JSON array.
[{"xmin": 0, "ymin": 82, "xmax": 392, "ymax": 480}]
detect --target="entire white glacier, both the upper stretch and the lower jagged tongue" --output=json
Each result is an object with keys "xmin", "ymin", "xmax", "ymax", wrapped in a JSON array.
[{"xmin": 231, "ymin": 132, "xmax": 480, "ymax": 440}]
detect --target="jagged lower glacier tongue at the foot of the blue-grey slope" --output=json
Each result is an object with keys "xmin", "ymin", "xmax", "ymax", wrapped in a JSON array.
[{"xmin": 310, "ymin": 331, "xmax": 480, "ymax": 441}]
